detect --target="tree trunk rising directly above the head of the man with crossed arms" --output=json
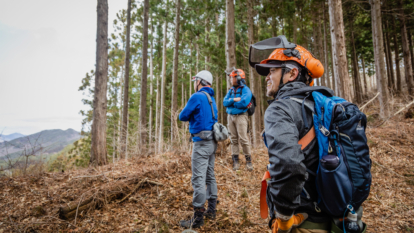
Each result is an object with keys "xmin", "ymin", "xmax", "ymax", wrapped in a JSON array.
[{"xmin": 226, "ymin": 0, "xmax": 237, "ymax": 89}]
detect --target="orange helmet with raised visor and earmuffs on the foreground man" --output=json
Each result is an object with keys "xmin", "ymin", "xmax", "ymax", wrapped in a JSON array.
[{"xmin": 249, "ymin": 35, "xmax": 324, "ymax": 86}]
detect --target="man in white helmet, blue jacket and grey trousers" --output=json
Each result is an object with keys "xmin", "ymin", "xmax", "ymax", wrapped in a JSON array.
[{"xmin": 179, "ymin": 70, "xmax": 218, "ymax": 228}]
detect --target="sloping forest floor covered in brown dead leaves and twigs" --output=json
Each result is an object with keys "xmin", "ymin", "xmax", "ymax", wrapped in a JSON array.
[{"xmin": 0, "ymin": 104, "xmax": 414, "ymax": 233}]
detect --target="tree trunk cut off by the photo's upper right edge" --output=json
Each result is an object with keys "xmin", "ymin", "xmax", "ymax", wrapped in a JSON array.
[{"xmin": 399, "ymin": 0, "xmax": 414, "ymax": 95}]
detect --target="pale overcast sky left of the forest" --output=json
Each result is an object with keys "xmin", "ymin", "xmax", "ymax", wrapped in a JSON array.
[{"xmin": 0, "ymin": 0, "xmax": 127, "ymax": 135}]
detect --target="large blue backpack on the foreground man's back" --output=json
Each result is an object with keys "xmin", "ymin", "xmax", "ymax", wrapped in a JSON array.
[{"xmin": 287, "ymin": 91, "xmax": 372, "ymax": 217}]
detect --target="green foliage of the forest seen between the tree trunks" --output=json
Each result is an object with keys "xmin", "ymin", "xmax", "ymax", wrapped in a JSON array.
[{"xmin": 78, "ymin": 0, "xmax": 414, "ymax": 166}]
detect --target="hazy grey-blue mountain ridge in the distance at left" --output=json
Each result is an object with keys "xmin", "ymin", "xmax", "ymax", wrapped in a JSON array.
[{"xmin": 0, "ymin": 129, "xmax": 81, "ymax": 158}]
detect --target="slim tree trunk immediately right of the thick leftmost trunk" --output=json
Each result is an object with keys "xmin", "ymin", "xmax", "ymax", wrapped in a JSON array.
[{"xmin": 120, "ymin": 0, "xmax": 131, "ymax": 159}]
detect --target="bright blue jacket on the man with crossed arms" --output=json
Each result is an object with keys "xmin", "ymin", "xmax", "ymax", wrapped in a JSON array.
[{"xmin": 223, "ymin": 84, "xmax": 253, "ymax": 115}]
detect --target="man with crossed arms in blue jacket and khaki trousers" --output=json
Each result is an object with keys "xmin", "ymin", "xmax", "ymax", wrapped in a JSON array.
[{"xmin": 223, "ymin": 69, "xmax": 253, "ymax": 170}]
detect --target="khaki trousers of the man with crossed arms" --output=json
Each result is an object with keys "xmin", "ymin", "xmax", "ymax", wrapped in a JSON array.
[{"xmin": 228, "ymin": 113, "xmax": 251, "ymax": 155}]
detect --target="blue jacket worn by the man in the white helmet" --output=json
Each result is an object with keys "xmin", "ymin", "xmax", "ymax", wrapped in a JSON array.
[{"xmin": 179, "ymin": 87, "xmax": 217, "ymax": 142}]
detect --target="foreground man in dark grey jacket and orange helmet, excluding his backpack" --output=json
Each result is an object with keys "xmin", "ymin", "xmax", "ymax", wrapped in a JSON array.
[{"xmin": 249, "ymin": 36, "xmax": 333, "ymax": 233}]
